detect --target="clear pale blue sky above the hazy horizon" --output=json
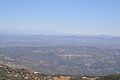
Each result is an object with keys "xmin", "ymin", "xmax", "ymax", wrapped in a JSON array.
[{"xmin": 0, "ymin": 0, "xmax": 120, "ymax": 36}]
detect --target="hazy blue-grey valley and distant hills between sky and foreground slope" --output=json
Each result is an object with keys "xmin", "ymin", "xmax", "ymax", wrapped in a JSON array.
[{"xmin": 0, "ymin": 35, "xmax": 120, "ymax": 75}]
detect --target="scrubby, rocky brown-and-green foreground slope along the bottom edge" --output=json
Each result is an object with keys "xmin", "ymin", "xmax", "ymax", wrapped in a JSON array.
[{"xmin": 0, "ymin": 64, "xmax": 120, "ymax": 80}]
